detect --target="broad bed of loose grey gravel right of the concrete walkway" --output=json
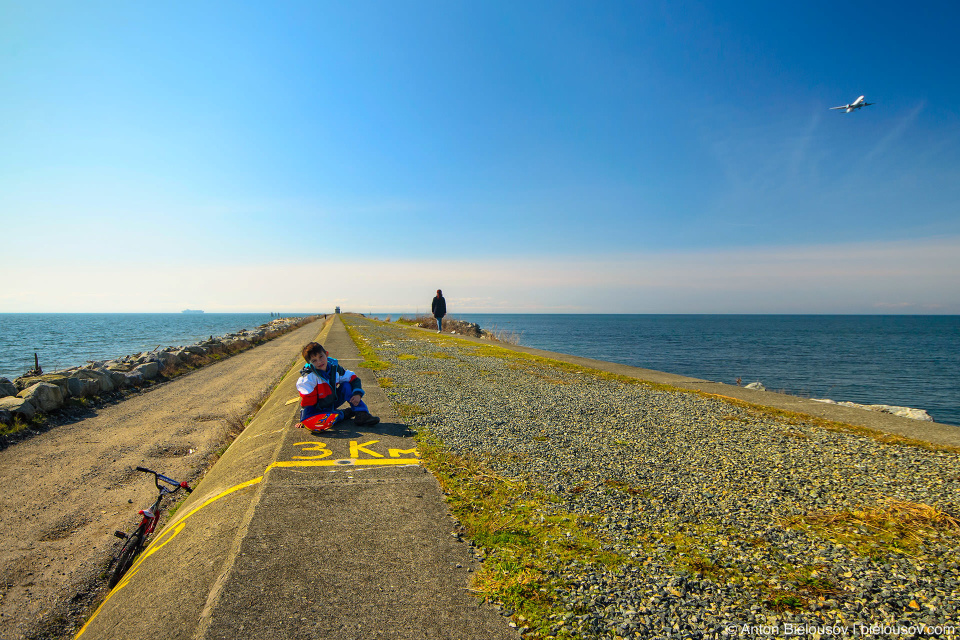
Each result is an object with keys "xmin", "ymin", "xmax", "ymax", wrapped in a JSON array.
[{"xmin": 351, "ymin": 320, "xmax": 960, "ymax": 638}]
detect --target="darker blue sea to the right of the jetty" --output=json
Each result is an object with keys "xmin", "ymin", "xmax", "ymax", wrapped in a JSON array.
[{"xmin": 376, "ymin": 314, "xmax": 960, "ymax": 425}]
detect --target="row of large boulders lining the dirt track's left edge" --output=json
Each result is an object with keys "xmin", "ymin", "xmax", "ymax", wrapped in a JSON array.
[{"xmin": 0, "ymin": 316, "xmax": 314, "ymax": 432}]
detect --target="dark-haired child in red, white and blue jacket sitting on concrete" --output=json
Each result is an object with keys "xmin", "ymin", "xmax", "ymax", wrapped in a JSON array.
[{"xmin": 297, "ymin": 342, "xmax": 380, "ymax": 431}]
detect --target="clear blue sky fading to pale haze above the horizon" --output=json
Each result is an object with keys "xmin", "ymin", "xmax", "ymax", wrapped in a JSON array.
[{"xmin": 0, "ymin": 0, "xmax": 960, "ymax": 314}]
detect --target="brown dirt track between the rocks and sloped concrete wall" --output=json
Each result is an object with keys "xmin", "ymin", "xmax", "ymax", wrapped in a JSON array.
[{"xmin": 0, "ymin": 320, "xmax": 323, "ymax": 640}]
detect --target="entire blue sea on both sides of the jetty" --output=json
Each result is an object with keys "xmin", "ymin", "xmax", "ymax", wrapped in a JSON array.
[{"xmin": 7, "ymin": 313, "xmax": 960, "ymax": 425}]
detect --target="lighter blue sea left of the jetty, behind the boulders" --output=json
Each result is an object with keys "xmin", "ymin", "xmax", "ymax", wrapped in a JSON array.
[{"xmin": 0, "ymin": 313, "xmax": 296, "ymax": 380}]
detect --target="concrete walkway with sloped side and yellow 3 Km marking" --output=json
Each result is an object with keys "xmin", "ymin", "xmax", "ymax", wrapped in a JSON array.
[{"xmin": 77, "ymin": 318, "xmax": 519, "ymax": 640}]
